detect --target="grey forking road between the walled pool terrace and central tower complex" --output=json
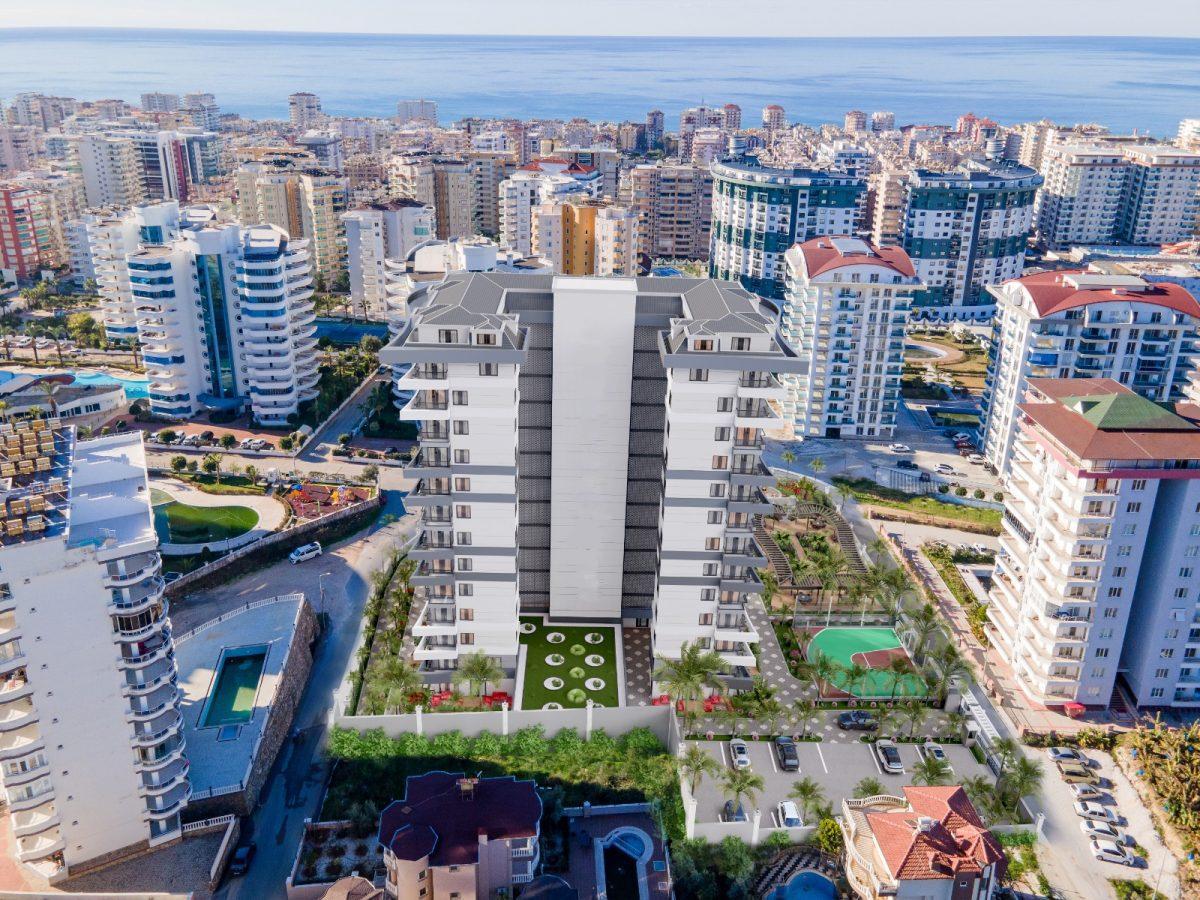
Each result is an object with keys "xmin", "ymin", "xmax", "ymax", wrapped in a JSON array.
[{"xmin": 206, "ymin": 497, "xmax": 416, "ymax": 900}]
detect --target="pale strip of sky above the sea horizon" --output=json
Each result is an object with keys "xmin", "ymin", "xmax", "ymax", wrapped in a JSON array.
[{"xmin": 7, "ymin": 0, "xmax": 1200, "ymax": 37}]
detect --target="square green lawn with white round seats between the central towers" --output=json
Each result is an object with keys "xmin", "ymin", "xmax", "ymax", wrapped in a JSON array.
[{"xmin": 521, "ymin": 616, "xmax": 619, "ymax": 709}]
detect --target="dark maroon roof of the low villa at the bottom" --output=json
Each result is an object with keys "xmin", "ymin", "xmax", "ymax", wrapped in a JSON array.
[{"xmin": 379, "ymin": 772, "xmax": 541, "ymax": 865}]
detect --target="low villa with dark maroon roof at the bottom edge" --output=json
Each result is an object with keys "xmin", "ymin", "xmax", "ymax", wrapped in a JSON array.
[{"xmin": 379, "ymin": 772, "xmax": 542, "ymax": 900}]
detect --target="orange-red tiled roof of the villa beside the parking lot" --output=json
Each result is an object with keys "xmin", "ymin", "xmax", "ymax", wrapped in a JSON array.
[{"xmin": 866, "ymin": 786, "xmax": 1004, "ymax": 881}]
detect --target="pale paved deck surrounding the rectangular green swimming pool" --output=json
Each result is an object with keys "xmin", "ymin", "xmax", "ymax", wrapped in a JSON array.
[{"xmin": 175, "ymin": 599, "xmax": 304, "ymax": 793}]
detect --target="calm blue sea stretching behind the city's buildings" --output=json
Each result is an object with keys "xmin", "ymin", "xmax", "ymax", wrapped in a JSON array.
[{"xmin": 0, "ymin": 28, "xmax": 1200, "ymax": 136}]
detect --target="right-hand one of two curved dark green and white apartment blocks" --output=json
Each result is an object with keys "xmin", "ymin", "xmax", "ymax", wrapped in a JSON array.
[{"xmin": 904, "ymin": 161, "xmax": 1042, "ymax": 318}]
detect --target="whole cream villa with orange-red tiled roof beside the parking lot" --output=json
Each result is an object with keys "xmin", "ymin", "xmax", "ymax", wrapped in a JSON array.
[{"xmin": 838, "ymin": 786, "xmax": 1007, "ymax": 900}]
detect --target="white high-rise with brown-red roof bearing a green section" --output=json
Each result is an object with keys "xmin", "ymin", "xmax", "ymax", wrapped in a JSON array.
[{"xmin": 988, "ymin": 378, "xmax": 1200, "ymax": 707}]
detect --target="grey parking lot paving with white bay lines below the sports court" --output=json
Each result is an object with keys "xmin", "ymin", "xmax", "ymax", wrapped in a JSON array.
[{"xmin": 696, "ymin": 734, "xmax": 991, "ymax": 824}]
